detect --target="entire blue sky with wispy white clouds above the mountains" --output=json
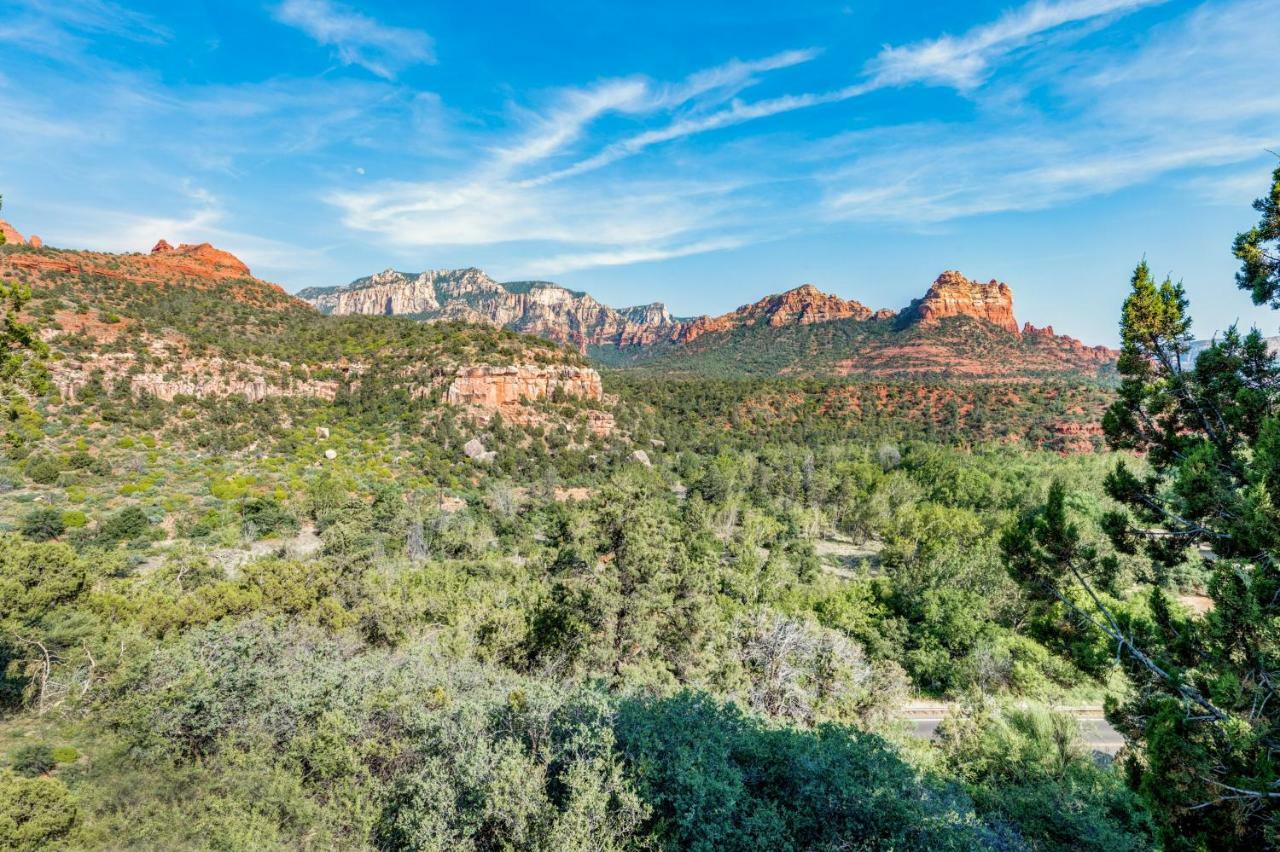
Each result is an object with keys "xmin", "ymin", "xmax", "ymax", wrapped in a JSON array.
[{"xmin": 0, "ymin": 0, "xmax": 1280, "ymax": 343}]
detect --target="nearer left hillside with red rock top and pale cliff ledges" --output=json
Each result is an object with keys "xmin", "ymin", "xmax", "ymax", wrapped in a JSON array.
[{"xmin": 0, "ymin": 228, "xmax": 612, "ymax": 447}]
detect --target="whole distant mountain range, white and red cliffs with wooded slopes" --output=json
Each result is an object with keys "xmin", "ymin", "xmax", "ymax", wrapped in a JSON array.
[{"xmin": 298, "ymin": 262, "xmax": 1115, "ymax": 381}]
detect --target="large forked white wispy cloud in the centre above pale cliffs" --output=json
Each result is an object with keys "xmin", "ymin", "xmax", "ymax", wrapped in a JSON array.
[{"xmin": 328, "ymin": 50, "xmax": 818, "ymax": 268}]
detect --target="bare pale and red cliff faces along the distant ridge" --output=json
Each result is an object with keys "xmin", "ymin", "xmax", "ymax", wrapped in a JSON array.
[{"xmin": 298, "ymin": 262, "xmax": 1115, "ymax": 376}]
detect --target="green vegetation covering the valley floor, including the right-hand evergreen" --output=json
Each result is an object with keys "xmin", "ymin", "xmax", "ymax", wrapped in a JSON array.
[{"xmin": 0, "ymin": 170, "xmax": 1280, "ymax": 849}]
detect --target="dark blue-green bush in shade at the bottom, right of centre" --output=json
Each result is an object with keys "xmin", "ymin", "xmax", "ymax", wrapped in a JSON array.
[{"xmin": 618, "ymin": 693, "xmax": 982, "ymax": 849}]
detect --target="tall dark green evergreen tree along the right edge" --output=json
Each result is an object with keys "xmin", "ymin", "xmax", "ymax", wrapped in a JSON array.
[{"xmin": 1004, "ymin": 163, "xmax": 1280, "ymax": 848}]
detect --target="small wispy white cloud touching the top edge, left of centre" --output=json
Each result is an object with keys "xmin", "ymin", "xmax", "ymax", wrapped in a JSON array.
[{"xmin": 275, "ymin": 0, "xmax": 435, "ymax": 79}]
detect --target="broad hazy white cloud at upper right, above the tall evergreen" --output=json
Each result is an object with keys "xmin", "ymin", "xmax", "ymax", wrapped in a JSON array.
[{"xmin": 820, "ymin": 1, "xmax": 1280, "ymax": 225}]
